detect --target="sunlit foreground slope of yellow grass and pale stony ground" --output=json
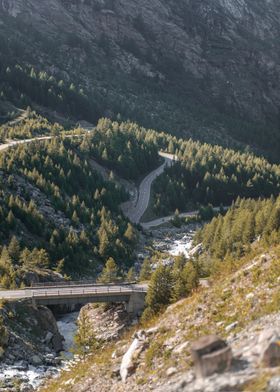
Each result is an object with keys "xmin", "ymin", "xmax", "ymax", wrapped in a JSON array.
[{"xmin": 38, "ymin": 246, "xmax": 280, "ymax": 392}]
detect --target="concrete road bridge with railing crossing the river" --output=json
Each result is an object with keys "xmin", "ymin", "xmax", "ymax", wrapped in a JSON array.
[{"xmin": 0, "ymin": 282, "xmax": 147, "ymax": 314}]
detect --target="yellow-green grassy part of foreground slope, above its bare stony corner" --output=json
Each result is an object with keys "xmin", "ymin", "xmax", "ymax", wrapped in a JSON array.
[{"xmin": 38, "ymin": 242, "xmax": 280, "ymax": 392}]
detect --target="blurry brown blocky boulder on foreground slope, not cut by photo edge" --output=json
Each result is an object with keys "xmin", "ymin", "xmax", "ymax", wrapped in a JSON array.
[{"xmin": 191, "ymin": 335, "xmax": 232, "ymax": 378}]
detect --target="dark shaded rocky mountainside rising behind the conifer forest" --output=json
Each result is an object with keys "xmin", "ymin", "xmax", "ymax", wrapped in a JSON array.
[{"xmin": 0, "ymin": 0, "xmax": 280, "ymax": 159}]
